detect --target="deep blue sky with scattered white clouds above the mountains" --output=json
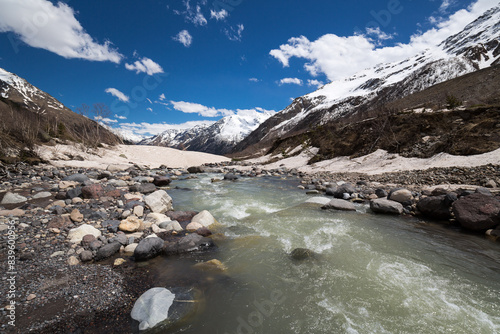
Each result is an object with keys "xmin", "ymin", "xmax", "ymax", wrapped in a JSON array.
[{"xmin": 0, "ymin": 0, "xmax": 498, "ymax": 140}]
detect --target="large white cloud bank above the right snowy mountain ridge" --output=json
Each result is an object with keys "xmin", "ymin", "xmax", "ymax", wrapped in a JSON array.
[{"xmin": 270, "ymin": 0, "xmax": 498, "ymax": 81}]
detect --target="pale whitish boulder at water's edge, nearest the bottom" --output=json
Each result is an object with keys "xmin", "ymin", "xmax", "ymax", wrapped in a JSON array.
[{"xmin": 130, "ymin": 288, "xmax": 175, "ymax": 330}]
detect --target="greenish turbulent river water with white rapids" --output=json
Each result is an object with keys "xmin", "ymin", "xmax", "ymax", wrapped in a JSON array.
[{"xmin": 150, "ymin": 175, "xmax": 500, "ymax": 334}]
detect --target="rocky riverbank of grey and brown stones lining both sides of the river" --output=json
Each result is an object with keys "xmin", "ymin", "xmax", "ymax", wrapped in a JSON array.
[{"xmin": 0, "ymin": 163, "xmax": 500, "ymax": 333}]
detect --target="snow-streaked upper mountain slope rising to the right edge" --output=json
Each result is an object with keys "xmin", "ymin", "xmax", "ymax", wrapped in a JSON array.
[{"xmin": 235, "ymin": 6, "xmax": 500, "ymax": 151}]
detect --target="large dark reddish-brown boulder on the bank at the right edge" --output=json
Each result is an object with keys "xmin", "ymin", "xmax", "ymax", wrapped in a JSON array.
[{"xmin": 453, "ymin": 193, "xmax": 500, "ymax": 231}]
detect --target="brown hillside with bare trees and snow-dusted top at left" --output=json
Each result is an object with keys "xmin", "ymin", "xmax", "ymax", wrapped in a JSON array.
[{"xmin": 0, "ymin": 68, "xmax": 121, "ymax": 161}]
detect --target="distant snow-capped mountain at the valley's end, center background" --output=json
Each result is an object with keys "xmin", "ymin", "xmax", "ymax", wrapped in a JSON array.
[{"xmin": 139, "ymin": 108, "xmax": 275, "ymax": 154}]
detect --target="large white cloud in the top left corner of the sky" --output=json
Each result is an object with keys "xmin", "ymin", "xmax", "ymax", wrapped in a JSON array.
[{"xmin": 0, "ymin": 0, "xmax": 123, "ymax": 63}]
